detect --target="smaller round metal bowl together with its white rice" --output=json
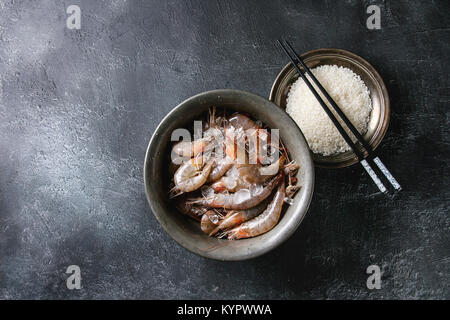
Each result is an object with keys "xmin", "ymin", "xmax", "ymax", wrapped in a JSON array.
[{"xmin": 269, "ymin": 49, "xmax": 390, "ymax": 168}]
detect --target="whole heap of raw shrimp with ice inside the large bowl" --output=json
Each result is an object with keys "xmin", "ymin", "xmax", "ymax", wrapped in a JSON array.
[{"xmin": 169, "ymin": 108, "xmax": 299, "ymax": 240}]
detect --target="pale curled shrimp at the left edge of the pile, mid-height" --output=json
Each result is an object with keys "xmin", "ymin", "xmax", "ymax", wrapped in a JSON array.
[{"xmin": 170, "ymin": 158, "xmax": 213, "ymax": 198}]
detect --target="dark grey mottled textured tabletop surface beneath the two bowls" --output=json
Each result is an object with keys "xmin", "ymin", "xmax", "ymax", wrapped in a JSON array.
[{"xmin": 0, "ymin": 0, "xmax": 450, "ymax": 299}]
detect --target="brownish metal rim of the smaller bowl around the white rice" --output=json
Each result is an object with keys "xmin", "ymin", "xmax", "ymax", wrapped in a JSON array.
[{"xmin": 269, "ymin": 49, "xmax": 390, "ymax": 168}]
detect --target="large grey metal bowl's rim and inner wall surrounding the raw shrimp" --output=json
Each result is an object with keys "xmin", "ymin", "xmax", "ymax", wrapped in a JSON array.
[{"xmin": 144, "ymin": 90, "xmax": 314, "ymax": 260}]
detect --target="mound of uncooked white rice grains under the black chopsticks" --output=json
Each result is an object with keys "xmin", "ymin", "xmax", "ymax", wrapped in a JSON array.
[{"xmin": 286, "ymin": 65, "xmax": 372, "ymax": 156}]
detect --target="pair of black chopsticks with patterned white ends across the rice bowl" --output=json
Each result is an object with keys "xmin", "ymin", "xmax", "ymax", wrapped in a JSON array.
[{"xmin": 277, "ymin": 40, "xmax": 401, "ymax": 193}]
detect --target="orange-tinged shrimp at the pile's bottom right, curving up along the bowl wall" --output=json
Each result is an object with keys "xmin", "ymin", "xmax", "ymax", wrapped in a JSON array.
[{"xmin": 222, "ymin": 180, "xmax": 285, "ymax": 240}]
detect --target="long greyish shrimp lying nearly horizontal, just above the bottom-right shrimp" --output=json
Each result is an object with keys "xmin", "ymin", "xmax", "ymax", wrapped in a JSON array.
[{"xmin": 191, "ymin": 174, "xmax": 282, "ymax": 210}]
